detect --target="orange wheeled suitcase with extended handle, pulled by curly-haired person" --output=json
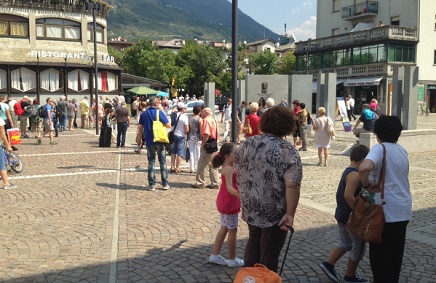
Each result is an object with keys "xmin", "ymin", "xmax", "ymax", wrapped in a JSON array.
[{"xmin": 233, "ymin": 227, "xmax": 294, "ymax": 283}]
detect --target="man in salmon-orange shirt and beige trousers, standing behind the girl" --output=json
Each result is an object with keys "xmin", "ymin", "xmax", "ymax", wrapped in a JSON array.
[{"xmin": 192, "ymin": 108, "xmax": 219, "ymax": 189}]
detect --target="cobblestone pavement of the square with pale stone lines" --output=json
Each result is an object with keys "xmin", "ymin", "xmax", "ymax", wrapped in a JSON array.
[{"xmin": 0, "ymin": 115, "xmax": 436, "ymax": 283}]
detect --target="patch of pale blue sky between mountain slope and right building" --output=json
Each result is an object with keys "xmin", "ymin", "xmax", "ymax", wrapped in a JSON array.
[{"xmin": 229, "ymin": 0, "xmax": 316, "ymax": 41}]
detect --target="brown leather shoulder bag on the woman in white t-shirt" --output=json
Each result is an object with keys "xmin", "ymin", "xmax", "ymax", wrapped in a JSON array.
[{"xmin": 347, "ymin": 144, "xmax": 386, "ymax": 243}]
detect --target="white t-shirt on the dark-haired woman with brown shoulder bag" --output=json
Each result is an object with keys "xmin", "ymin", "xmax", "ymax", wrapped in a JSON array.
[{"xmin": 366, "ymin": 142, "xmax": 412, "ymax": 222}]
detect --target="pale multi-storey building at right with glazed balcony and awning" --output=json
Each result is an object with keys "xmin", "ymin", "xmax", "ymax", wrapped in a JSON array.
[{"xmin": 295, "ymin": 0, "xmax": 436, "ymax": 114}]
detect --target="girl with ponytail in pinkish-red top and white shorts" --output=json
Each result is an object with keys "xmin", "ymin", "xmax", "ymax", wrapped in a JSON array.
[{"xmin": 209, "ymin": 143, "xmax": 244, "ymax": 267}]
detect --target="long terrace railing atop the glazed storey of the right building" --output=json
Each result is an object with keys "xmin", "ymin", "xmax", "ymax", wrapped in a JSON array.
[{"xmin": 295, "ymin": 26, "xmax": 418, "ymax": 54}]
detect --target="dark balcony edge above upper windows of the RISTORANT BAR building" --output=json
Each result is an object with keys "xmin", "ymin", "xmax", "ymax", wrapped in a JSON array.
[{"xmin": 0, "ymin": 0, "xmax": 109, "ymax": 19}]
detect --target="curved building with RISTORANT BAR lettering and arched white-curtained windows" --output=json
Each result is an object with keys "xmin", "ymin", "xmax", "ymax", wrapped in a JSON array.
[{"xmin": 0, "ymin": 0, "xmax": 121, "ymax": 103}]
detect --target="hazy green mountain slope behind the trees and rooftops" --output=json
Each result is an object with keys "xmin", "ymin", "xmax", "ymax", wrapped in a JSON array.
[{"xmin": 107, "ymin": 0, "xmax": 279, "ymax": 42}]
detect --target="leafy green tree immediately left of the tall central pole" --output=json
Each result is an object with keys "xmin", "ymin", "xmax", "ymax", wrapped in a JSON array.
[{"xmin": 176, "ymin": 40, "xmax": 225, "ymax": 95}]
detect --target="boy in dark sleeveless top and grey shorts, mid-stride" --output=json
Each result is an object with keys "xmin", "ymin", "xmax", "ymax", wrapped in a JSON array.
[{"xmin": 320, "ymin": 145, "xmax": 369, "ymax": 283}]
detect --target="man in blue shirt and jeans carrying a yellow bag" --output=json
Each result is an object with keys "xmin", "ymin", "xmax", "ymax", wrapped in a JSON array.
[{"xmin": 138, "ymin": 96, "xmax": 171, "ymax": 191}]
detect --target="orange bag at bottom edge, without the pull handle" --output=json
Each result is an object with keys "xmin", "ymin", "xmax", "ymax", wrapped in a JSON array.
[{"xmin": 233, "ymin": 263, "xmax": 282, "ymax": 283}]
